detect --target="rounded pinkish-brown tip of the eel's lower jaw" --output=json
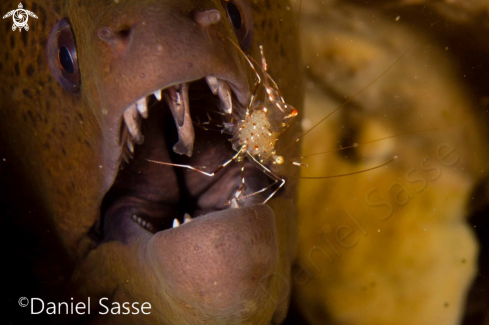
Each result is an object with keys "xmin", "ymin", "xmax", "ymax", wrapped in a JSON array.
[{"xmin": 145, "ymin": 205, "xmax": 278, "ymax": 321}]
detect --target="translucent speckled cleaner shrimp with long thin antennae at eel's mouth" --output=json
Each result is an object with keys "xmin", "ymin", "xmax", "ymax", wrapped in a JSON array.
[{"xmin": 146, "ymin": 41, "xmax": 398, "ymax": 206}]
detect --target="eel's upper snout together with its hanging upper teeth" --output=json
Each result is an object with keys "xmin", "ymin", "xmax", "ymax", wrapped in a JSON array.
[{"xmin": 87, "ymin": 0, "xmax": 256, "ymax": 184}]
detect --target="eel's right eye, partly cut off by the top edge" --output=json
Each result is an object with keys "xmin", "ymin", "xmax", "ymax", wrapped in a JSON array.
[{"xmin": 221, "ymin": 0, "xmax": 253, "ymax": 51}]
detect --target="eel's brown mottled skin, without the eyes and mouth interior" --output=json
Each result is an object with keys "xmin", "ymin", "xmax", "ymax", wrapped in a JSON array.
[{"xmin": 0, "ymin": 0, "xmax": 302, "ymax": 324}]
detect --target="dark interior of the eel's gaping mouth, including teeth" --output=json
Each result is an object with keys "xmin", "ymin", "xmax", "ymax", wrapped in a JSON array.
[{"xmin": 101, "ymin": 77, "xmax": 272, "ymax": 240}]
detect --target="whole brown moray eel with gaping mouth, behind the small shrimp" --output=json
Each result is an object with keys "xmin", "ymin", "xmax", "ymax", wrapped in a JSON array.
[{"xmin": 0, "ymin": 0, "xmax": 302, "ymax": 324}]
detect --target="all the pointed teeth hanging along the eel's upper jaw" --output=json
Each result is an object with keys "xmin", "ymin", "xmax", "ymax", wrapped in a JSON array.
[{"xmin": 121, "ymin": 76, "xmax": 237, "ymax": 160}]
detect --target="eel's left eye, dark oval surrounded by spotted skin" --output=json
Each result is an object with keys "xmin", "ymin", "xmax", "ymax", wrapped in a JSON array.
[{"xmin": 47, "ymin": 19, "xmax": 80, "ymax": 93}]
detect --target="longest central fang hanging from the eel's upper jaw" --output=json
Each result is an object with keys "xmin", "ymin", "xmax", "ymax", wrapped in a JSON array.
[{"xmin": 166, "ymin": 84, "xmax": 195, "ymax": 157}]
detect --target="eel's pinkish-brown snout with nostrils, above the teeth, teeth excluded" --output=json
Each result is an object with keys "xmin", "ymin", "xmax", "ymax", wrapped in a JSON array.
[{"xmin": 92, "ymin": 1, "xmax": 254, "ymax": 111}]
